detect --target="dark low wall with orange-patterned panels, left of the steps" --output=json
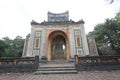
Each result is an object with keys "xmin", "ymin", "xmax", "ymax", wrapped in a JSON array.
[{"xmin": 0, "ymin": 56, "xmax": 39, "ymax": 73}]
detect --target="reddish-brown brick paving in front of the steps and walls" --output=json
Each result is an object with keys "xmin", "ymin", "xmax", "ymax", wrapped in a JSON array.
[{"xmin": 0, "ymin": 70, "xmax": 120, "ymax": 80}]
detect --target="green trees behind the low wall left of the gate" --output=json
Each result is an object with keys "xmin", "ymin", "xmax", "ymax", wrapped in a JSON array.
[{"xmin": 0, "ymin": 36, "xmax": 24, "ymax": 57}]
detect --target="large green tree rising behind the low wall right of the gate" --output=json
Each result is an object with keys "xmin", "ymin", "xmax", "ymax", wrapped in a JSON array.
[{"xmin": 93, "ymin": 18, "xmax": 120, "ymax": 53}]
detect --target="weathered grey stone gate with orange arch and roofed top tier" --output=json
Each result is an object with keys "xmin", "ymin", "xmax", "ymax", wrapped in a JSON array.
[{"xmin": 23, "ymin": 11, "xmax": 92, "ymax": 61}]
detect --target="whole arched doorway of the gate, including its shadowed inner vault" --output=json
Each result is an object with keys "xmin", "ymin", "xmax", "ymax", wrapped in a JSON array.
[{"xmin": 48, "ymin": 31, "xmax": 69, "ymax": 60}]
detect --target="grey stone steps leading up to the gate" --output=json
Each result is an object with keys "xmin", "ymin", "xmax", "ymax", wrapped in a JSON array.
[{"xmin": 34, "ymin": 61, "xmax": 77, "ymax": 74}]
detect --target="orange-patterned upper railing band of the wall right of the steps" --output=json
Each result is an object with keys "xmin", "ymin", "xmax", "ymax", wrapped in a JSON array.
[{"xmin": 78, "ymin": 56, "xmax": 120, "ymax": 64}]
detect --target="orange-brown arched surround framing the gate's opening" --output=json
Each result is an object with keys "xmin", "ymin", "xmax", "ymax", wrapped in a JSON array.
[{"xmin": 46, "ymin": 30, "xmax": 70, "ymax": 61}]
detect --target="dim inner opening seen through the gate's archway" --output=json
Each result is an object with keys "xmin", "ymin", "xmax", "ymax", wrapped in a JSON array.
[{"xmin": 52, "ymin": 35, "xmax": 66, "ymax": 59}]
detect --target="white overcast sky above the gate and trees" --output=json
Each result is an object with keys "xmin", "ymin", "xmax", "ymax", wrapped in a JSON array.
[{"xmin": 0, "ymin": 0, "xmax": 120, "ymax": 39}]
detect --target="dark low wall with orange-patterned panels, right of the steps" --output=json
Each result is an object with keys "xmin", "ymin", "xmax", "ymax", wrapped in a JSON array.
[{"xmin": 76, "ymin": 56, "xmax": 120, "ymax": 71}]
